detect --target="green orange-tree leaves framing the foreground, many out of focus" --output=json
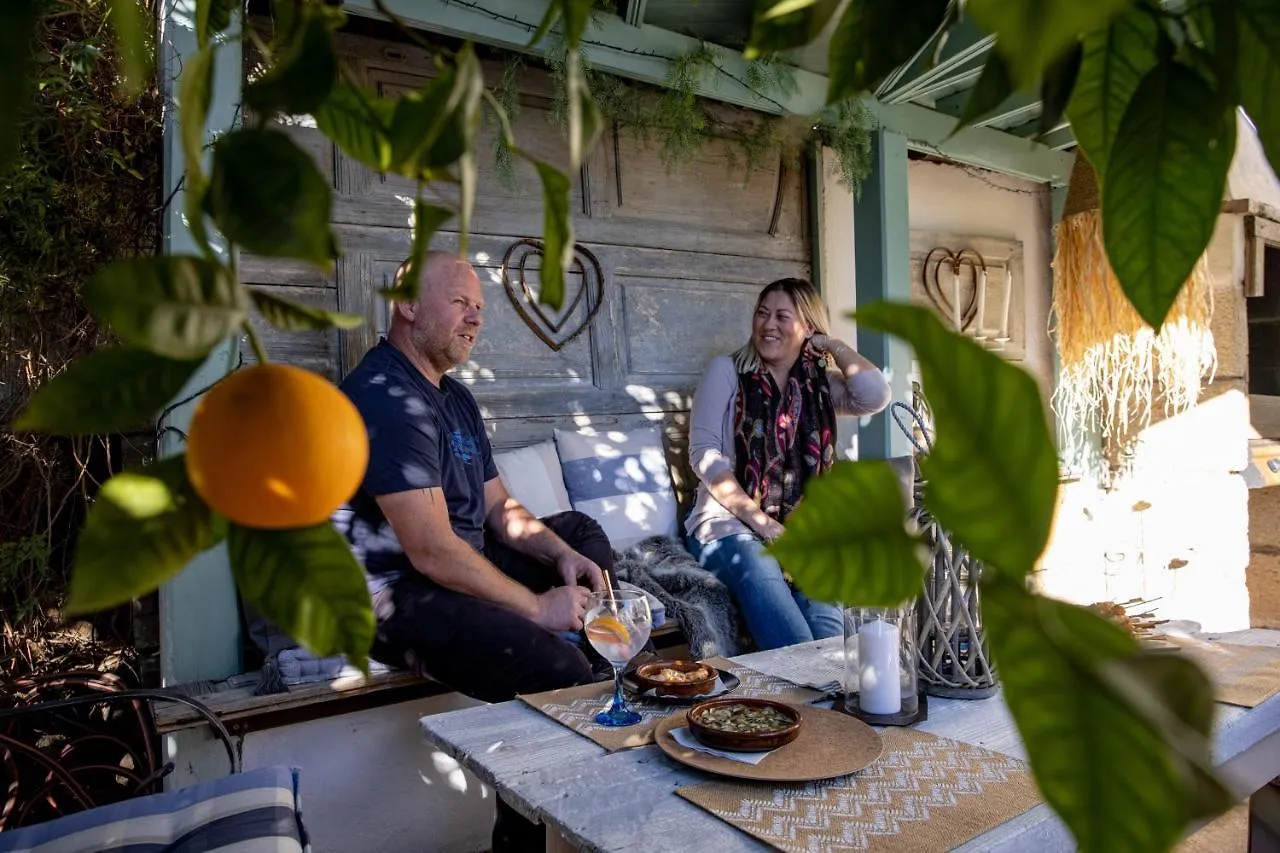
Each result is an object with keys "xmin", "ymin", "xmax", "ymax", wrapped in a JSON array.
[{"xmin": 0, "ymin": 0, "xmax": 1280, "ymax": 850}]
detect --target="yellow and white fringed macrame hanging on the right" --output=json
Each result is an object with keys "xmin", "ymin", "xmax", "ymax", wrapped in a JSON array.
[{"xmin": 1050, "ymin": 155, "xmax": 1217, "ymax": 473}]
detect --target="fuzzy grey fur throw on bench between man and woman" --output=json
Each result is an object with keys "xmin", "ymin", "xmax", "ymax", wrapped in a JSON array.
[{"xmin": 614, "ymin": 537, "xmax": 745, "ymax": 660}]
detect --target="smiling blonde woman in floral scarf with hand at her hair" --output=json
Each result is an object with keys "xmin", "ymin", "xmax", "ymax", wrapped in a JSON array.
[{"xmin": 685, "ymin": 278, "xmax": 890, "ymax": 649}]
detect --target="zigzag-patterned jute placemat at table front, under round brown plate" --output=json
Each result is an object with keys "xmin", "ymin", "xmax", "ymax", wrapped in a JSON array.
[{"xmin": 676, "ymin": 727, "xmax": 1042, "ymax": 853}]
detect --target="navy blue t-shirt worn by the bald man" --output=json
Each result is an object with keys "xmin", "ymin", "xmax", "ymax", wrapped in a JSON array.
[{"xmin": 338, "ymin": 338, "xmax": 498, "ymax": 592}]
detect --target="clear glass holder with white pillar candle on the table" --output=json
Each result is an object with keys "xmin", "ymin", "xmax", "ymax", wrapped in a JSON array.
[{"xmin": 845, "ymin": 602, "xmax": 919, "ymax": 719}]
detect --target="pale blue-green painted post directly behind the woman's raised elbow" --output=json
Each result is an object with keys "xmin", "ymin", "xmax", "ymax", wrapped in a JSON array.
[{"xmin": 854, "ymin": 128, "xmax": 911, "ymax": 459}]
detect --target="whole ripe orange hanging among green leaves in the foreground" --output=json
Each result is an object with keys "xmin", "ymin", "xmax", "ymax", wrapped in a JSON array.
[{"xmin": 187, "ymin": 364, "xmax": 369, "ymax": 529}]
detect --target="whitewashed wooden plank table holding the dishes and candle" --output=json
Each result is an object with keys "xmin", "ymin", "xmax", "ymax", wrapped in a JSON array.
[{"xmin": 421, "ymin": 630, "xmax": 1280, "ymax": 853}]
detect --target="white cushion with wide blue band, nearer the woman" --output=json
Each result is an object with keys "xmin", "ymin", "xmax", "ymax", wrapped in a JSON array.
[{"xmin": 556, "ymin": 427, "xmax": 676, "ymax": 551}]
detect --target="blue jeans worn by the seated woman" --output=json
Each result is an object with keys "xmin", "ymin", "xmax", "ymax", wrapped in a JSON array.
[{"xmin": 687, "ymin": 533, "xmax": 845, "ymax": 651}]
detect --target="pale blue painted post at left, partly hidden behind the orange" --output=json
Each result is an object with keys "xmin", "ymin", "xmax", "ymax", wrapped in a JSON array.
[{"xmin": 159, "ymin": 0, "xmax": 241, "ymax": 685}]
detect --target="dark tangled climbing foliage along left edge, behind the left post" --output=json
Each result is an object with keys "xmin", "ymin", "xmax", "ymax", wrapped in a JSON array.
[{"xmin": 0, "ymin": 0, "xmax": 168, "ymax": 678}]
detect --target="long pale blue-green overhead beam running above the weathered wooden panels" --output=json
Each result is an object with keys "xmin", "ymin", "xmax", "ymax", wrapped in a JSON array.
[{"xmin": 343, "ymin": 0, "xmax": 1070, "ymax": 183}]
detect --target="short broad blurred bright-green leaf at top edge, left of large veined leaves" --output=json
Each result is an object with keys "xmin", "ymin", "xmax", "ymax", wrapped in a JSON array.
[{"xmin": 965, "ymin": 0, "xmax": 1133, "ymax": 87}]
